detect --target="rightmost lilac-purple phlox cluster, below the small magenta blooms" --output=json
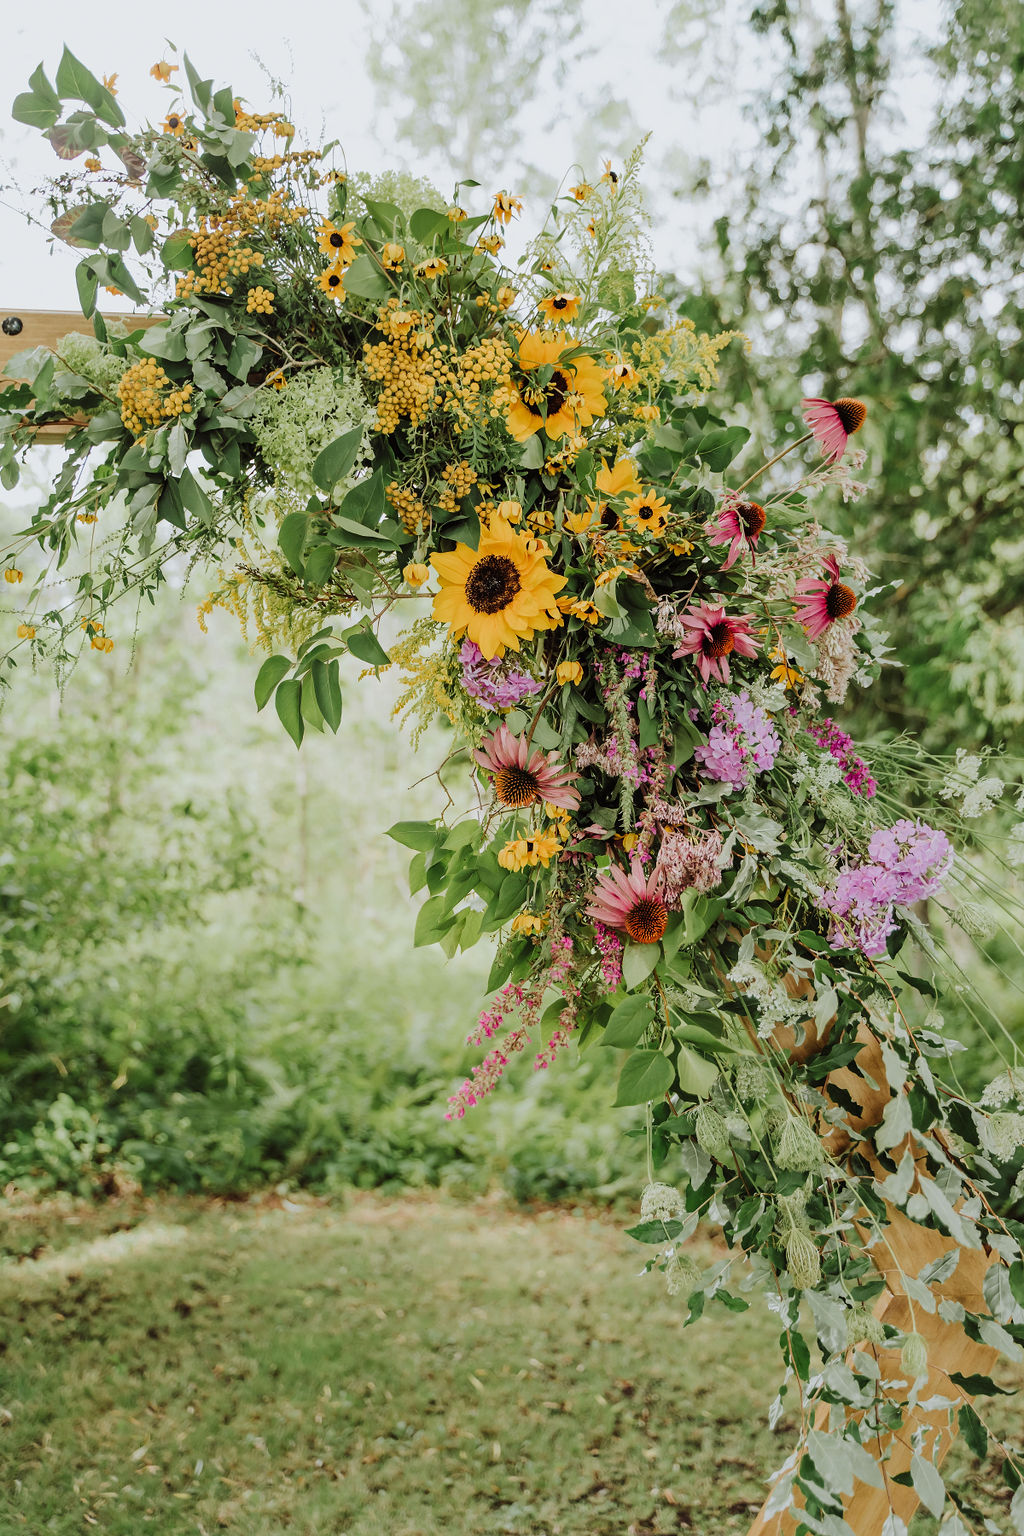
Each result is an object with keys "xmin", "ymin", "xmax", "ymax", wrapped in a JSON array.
[{"xmin": 821, "ymin": 819, "xmax": 953, "ymax": 955}]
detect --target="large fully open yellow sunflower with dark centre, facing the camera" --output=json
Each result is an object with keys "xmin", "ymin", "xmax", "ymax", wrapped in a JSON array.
[{"xmin": 430, "ymin": 516, "xmax": 565, "ymax": 662}]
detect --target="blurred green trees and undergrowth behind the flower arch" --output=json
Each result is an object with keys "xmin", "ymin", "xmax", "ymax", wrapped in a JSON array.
[{"xmin": 0, "ymin": 0, "xmax": 1024, "ymax": 1198}]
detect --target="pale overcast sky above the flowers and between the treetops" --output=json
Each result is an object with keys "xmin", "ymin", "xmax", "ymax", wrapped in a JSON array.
[{"xmin": 0, "ymin": 0, "xmax": 935, "ymax": 313}]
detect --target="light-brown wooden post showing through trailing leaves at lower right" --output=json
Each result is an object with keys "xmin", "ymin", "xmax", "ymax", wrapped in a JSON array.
[{"xmin": 749, "ymin": 1031, "xmax": 999, "ymax": 1536}]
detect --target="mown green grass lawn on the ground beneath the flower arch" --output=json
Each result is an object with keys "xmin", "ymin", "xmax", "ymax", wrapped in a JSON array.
[{"xmin": 0, "ymin": 1195, "xmax": 1016, "ymax": 1536}]
